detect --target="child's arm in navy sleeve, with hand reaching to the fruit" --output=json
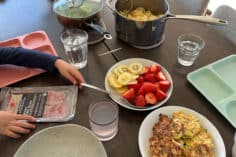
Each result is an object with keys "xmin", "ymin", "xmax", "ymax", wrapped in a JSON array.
[{"xmin": 0, "ymin": 47, "xmax": 85, "ymax": 84}]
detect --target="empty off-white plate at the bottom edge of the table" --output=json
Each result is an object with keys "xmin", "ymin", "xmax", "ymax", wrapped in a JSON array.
[{"xmin": 14, "ymin": 124, "xmax": 107, "ymax": 157}]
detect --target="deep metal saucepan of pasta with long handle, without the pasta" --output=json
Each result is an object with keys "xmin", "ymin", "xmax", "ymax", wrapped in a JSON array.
[{"xmin": 106, "ymin": 0, "xmax": 227, "ymax": 46}]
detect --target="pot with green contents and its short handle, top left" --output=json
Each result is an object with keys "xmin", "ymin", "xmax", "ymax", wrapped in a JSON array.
[{"xmin": 53, "ymin": 0, "xmax": 112, "ymax": 39}]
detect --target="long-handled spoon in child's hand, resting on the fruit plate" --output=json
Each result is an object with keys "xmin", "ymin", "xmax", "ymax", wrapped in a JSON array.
[{"xmin": 81, "ymin": 83, "xmax": 147, "ymax": 109}]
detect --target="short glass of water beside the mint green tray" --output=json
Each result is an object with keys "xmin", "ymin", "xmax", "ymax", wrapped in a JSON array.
[{"xmin": 178, "ymin": 34, "xmax": 205, "ymax": 66}]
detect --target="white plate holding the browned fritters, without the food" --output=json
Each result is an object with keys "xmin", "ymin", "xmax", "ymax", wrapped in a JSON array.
[{"xmin": 138, "ymin": 106, "xmax": 226, "ymax": 157}]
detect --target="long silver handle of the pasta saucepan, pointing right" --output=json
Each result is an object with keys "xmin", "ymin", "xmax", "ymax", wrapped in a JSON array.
[{"xmin": 167, "ymin": 15, "xmax": 228, "ymax": 25}]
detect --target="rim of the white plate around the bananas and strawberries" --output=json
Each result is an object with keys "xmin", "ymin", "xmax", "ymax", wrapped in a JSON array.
[{"xmin": 104, "ymin": 58, "xmax": 174, "ymax": 111}]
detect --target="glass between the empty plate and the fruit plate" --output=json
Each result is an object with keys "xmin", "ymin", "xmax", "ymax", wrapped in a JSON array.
[{"xmin": 88, "ymin": 101, "xmax": 119, "ymax": 141}]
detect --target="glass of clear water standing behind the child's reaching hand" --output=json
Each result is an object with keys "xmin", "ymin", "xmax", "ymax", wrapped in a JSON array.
[{"xmin": 61, "ymin": 29, "xmax": 88, "ymax": 69}]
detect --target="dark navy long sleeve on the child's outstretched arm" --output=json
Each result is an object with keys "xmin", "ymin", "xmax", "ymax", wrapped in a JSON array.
[{"xmin": 0, "ymin": 47, "xmax": 59, "ymax": 72}]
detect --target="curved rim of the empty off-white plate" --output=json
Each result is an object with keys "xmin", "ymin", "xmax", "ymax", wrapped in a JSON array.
[{"xmin": 13, "ymin": 123, "xmax": 107, "ymax": 157}]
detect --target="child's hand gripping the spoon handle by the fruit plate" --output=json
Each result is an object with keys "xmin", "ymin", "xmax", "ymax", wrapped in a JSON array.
[{"xmin": 55, "ymin": 59, "xmax": 85, "ymax": 84}]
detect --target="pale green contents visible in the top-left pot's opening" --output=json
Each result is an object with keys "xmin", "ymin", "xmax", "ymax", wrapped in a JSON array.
[{"xmin": 54, "ymin": 1, "xmax": 102, "ymax": 18}]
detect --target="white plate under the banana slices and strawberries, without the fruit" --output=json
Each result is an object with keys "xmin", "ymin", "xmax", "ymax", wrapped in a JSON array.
[{"xmin": 105, "ymin": 58, "xmax": 173, "ymax": 111}]
